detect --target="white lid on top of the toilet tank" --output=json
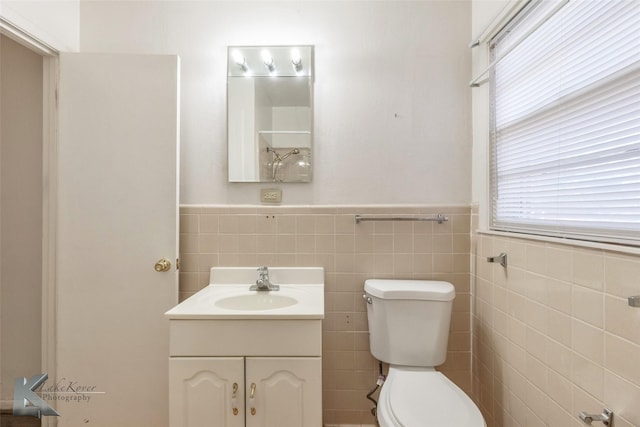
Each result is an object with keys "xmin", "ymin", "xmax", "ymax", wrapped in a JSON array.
[{"xmin": 364, "ymin": 279, "xmax": 456, "ymax": 301}]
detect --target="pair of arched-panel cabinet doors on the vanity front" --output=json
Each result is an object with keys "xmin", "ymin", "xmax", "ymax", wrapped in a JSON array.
[{"xmin": 169, "ymin": 357, "xmax": 322, "ymax": 427}]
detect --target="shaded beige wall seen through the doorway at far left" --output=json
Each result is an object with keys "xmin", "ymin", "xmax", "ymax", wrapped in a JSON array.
[{"xmin": 0, "ymin": 36, "xmax": 42, "ymax": 401}]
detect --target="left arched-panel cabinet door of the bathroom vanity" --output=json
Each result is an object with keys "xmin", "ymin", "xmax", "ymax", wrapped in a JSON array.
[{"xmin": 169, "ymin": 357, "xmax": 244, "ymax": 427}]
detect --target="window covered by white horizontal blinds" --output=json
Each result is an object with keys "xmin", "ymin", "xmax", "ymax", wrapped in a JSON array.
[{"xmin": 490, "ymin": 0, "xmax": 640, "ymax": 246}]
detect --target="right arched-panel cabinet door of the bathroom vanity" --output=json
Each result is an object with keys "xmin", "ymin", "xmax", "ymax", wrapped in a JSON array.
[{"xmin": 245, "ymin": 357, "xmax": 322, "ymax": 427}]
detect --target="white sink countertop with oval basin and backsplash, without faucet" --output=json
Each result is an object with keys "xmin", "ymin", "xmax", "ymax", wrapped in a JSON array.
[{"xmin": 165, "ymin": 267, "xmax": 324, "ymax": 319}]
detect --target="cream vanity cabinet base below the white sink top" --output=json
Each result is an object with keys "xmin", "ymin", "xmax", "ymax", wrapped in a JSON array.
[{"xmin": 169, "ymin": 319, "xmax": 322, "ymax": 427}]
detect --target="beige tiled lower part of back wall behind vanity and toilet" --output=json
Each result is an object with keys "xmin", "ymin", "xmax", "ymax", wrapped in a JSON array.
[{"xmin": 180, "ymin": 206, "xmax": 471, "ymax": 424}]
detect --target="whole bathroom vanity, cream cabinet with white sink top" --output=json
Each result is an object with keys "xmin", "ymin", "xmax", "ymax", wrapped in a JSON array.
[{"xmin": 165, "ymin": 267, "xmax": 324, "ymax": 427}]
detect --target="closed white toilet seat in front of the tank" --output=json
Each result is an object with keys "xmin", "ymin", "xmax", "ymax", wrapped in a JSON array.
[{"xmin": 377, "ymin": 366, "xmax": 486, "ymax": 427}]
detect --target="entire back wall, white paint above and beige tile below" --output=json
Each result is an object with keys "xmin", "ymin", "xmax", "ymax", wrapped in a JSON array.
[{"xmin": 76, "ymin": 1, "xmax": 471, "ymax": 424}]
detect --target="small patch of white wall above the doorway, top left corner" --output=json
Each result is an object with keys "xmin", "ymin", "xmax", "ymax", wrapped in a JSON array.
[{"xmin": 0, "ymin": 0, "xmax": 80, "ymax": 52}]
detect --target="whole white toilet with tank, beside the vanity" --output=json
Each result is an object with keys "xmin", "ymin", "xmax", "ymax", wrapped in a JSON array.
[{"xmin": 364, "ymin": 279, "xmax": 486, "ymax": 427}]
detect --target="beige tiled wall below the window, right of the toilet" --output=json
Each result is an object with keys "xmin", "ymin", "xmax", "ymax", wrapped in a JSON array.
[{"xmin": 472, "ymin": 215, "xmax": 640, "ymax": 427}]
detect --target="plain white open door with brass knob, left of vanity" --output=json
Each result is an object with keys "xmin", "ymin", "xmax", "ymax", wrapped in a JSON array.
[{"xmin": 56, "ymin": 54, "xmax": 179, "ymax": 427}]
